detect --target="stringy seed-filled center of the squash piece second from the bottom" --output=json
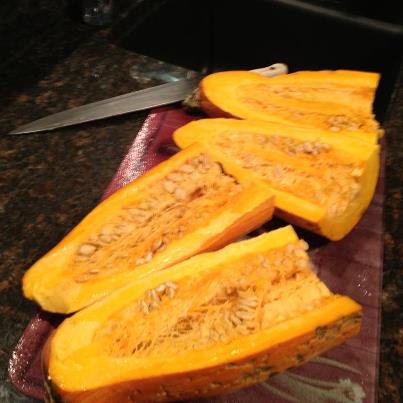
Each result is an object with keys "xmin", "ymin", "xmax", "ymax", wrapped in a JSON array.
[{"xmin": 69, "ymin": 153, "xmax": 243, "ymax": 284}]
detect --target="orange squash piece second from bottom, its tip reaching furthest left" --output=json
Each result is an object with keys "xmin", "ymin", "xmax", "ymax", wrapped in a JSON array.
[{"xmin": 23, "ymin": 145, "xmax": 274, "ymax": 313}]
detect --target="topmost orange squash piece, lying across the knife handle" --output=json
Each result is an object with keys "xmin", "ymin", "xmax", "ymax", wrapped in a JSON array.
[{"xmin": 200, "ymin": 70, "xmax": 381, "ymax": 143}]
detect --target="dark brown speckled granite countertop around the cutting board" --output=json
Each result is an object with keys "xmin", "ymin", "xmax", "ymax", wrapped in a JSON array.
[{"xmin": 0, "ymin": 1, "xmax": 403, "ymax": 402}]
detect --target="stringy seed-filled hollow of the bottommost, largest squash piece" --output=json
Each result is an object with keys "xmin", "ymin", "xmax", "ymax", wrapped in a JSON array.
[{"xmin": 95, "ymin": 241, "xmax": 331, "ymax": 358}]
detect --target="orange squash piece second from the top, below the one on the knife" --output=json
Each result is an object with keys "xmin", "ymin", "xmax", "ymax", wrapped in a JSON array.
[{"xmin": 174, "ymin": 119, "xmax": 379, "ymax": 240}]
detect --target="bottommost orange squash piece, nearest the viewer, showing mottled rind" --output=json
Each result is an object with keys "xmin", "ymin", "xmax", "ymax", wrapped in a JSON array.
[{"xmin": 44, "ymin": 227, "xmax": 361, "ymax": 403}]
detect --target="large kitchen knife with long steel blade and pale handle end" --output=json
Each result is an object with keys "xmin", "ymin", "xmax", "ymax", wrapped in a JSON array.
[{"xmin": 8, "ymin": 63, "xmax": 287, "ymax": 134}]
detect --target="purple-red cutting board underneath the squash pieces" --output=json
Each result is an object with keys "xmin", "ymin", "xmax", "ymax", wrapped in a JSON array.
[{"xmin": 9, "ymin": 107, "xmax": 384, "ymax": 403}]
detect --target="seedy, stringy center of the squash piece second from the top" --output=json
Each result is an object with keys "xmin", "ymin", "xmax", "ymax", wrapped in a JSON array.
[{"xmin": 214, "ymin": 133, "xmax": 364, "ymax": 215}]
